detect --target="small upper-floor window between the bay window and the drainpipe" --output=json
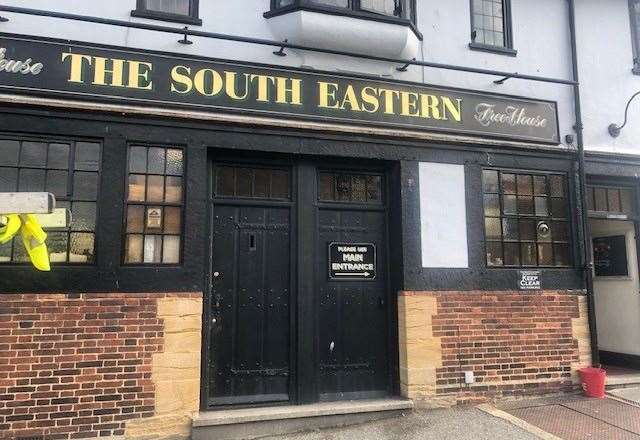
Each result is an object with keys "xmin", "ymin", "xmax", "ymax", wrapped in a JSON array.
[{"xmin": 470, "ymin": 0, "xmax": 516, "ymax": 55}]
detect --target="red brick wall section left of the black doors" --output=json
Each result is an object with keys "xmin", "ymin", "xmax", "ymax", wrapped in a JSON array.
[{"xmin": 0, "ymin": 294, "xmax": 199, "ymax": 439}]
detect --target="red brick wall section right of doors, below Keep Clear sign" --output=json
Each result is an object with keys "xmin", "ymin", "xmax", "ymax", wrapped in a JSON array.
[{"xmin": 432, "ymin": 292, "xmax": 580, "ymax": 403}]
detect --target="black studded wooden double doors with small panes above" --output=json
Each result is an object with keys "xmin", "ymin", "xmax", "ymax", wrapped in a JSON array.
[{"xmin": 206, "ymin": 158, "xmax": 393, "ymax": 406}]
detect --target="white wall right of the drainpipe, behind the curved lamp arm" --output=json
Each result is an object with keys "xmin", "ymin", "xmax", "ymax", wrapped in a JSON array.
[{"xmin": 576, "ymin": 0, "xmax": 640, "ymax": 154}]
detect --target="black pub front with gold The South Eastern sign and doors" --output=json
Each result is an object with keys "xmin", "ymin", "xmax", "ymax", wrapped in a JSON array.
[{"xmin": 0, "ymin": 35, "xmax": 581, "ymax": 408}]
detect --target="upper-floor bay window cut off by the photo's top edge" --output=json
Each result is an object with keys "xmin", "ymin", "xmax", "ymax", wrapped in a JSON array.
[{"xmin": 271, "ymin": 0, "xmax": 415, "ymax": 23}]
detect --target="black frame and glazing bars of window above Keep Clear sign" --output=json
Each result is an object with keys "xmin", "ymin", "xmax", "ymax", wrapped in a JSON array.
[{"xmin": 481, "ymin": 167, "xmax": 575, "ymax": 270}]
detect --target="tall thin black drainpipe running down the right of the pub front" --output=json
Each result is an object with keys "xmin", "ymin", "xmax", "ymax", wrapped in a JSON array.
[{"xmin": 568, "ymin": 0, "xmax": 600, "ymax": 365}]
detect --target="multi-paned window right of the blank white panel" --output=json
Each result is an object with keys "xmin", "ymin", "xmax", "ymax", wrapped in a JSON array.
[{"xmin": 482, "ymin": 170, "xmax": 572, "ymax": 267}]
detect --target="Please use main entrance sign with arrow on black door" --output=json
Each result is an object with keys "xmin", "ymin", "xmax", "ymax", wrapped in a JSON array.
[{"xmin": 329, "ymin": 243, "xmax": 377, "ymax": 280}]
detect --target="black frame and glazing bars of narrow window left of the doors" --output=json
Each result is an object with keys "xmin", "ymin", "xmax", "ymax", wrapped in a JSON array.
[{"xmin": 120, "ymin": 142, "xmax": 187, "ymax": 268}]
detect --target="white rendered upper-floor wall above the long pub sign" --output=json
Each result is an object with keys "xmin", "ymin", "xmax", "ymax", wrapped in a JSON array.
[{"xmin": 0, "ymin": 0, "xmax": 576, "ymax": 150}]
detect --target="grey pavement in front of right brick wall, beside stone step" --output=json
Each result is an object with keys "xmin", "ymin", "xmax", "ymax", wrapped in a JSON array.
[{"xmin": 263, "ymin": 407, "xmax": 540, "ymax": 440}]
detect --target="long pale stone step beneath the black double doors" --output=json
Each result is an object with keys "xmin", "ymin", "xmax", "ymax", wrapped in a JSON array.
[{"xmin": 191, "ymin": 398, "xmax": 413, "ymax": 440}]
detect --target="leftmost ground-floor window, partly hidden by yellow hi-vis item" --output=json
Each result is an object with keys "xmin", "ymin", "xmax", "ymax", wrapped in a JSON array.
[{"xmin": 0, "ymin": 136, "xmax": 101, "ymax": 264}]
